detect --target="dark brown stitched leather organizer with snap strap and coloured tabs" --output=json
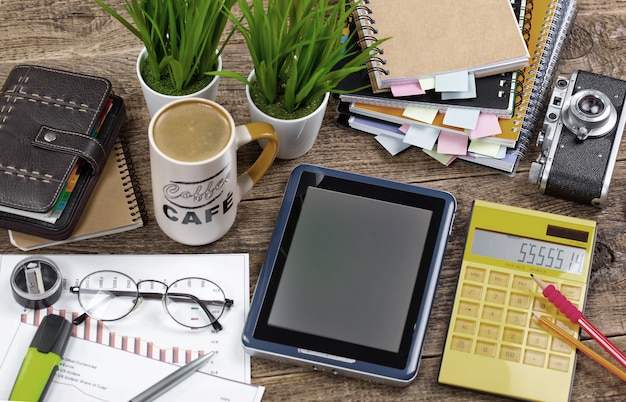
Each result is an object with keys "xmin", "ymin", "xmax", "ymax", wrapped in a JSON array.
[{"xmin": 0, "ymin": 65, "xmax": 126, "ymax": 240}]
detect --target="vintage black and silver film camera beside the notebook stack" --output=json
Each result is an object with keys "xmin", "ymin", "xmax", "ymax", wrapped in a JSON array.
[{"xmin": 528, "ymin": 70, "xmax": 626, "ymax": 208}]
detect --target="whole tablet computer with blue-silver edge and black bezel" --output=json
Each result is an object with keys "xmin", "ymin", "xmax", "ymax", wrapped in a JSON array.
[{"xmin": 243, "ymin": 165, "xmax": 456, "ymax": 386}]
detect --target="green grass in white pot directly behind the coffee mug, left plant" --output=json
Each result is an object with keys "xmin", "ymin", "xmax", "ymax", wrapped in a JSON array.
[{"xmin": 95, "ymin": 0, "xmax": 237, "ymax": 115}]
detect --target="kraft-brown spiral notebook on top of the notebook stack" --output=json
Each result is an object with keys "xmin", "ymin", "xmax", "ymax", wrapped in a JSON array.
[{"xmin": 356, "ymin": 0, "xmax": 529, "ymax": 91}]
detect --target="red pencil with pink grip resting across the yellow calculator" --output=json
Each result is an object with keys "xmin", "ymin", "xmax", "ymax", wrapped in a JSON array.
[{"xmin": 530, "ymin": 274, "xmax": 626, "ymax": 367}]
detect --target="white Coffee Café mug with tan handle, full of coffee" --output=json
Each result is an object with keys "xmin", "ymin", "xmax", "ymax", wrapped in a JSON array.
[{"xmin": 148, "ymin": 98, "xmax": 278, "ymax": 246}]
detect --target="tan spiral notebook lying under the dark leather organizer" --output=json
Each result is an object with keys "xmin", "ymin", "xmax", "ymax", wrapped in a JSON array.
[{"xmin": 9, "ymin": 137, "xmax": 145, "ymax": 251}]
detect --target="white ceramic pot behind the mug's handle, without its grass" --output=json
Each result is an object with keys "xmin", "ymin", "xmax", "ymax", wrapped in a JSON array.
[{"xmin": 246, "ymin": 71, "xmax": 330, "ymax": 159}]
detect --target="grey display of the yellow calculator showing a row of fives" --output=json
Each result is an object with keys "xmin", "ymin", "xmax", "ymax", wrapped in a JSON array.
[{"xmin": 471, "ymin": 229, "xmax": 586, "ymax": 274}]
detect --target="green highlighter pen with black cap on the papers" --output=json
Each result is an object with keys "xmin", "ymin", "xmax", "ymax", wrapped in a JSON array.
[{"xmin": 9, "ymin": 314, "xmax": 72, "ymax": 402}]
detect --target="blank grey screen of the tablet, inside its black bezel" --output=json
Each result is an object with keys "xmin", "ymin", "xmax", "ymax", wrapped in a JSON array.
[{"xmin": 268, "ymin": 187, "xmax": 432, "ymax": 352}]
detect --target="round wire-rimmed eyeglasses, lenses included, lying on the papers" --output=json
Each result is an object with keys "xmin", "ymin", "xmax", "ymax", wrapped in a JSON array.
[{"xmin": 70, "ymin": 271, "xmax": 233, "ymax": 331}]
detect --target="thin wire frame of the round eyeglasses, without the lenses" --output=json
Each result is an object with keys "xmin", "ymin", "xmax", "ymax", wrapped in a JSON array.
[{"xmin": 69, "ymin": 269, "xmax": 234, "ymax": 331}]
